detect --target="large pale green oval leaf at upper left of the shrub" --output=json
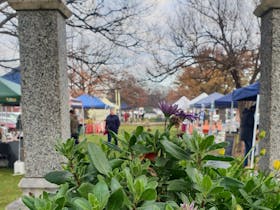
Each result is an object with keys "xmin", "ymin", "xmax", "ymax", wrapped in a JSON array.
[{"xmin": 88, "ymin": 142, "xmax": 112, "ymax": 176}]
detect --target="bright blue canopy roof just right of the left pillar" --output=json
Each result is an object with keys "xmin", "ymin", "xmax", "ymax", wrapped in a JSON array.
[{"xmin": 75, "ymin": 94, "xmax": 106, "ymax": 109}]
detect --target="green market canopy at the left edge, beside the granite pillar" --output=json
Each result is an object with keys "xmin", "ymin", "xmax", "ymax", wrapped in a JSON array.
[{"xmin": 0, "ymin": 77, "xmax": 21, "ymax": 106}]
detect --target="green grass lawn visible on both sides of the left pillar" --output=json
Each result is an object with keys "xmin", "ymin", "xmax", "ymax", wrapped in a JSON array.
[{"xmin": 0, "ymin": 123, "xmax": 168, "ymax": 210}]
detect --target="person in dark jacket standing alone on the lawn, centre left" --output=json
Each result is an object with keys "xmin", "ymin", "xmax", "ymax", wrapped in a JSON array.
[{"xmin": 105, "ymin": 108, "xmax": 121, "ymax": 145}]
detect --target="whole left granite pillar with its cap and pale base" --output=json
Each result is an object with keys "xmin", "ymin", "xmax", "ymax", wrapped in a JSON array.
[{"xmin": 8, "ymin": 0, "xmax": 71, "ymax": 209}]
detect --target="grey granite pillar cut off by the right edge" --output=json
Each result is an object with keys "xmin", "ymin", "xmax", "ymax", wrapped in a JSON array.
[{"xmin": 255, "ymin": 0, "xmax": 280, "ymax": 170}]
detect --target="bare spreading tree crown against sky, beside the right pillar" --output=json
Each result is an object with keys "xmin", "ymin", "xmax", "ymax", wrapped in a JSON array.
[{"xmin": 148, "ymin": 0, "xmax": 260, "ymax": 88}]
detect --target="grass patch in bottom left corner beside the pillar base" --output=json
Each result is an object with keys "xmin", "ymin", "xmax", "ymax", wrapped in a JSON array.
[{"xmin": 0, "ymin": 168, "xmax": 22, "ymax": 210}]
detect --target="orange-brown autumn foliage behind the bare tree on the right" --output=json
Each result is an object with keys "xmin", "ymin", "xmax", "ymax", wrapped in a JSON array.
[{"xmin": 168, "ymin": 49, "xmax": 243, "ymax": 101}]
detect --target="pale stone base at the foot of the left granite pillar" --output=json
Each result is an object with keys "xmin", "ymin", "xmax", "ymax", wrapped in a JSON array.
[{"xmin": 6, "ymin": 178, "xmax": 58, "ymax": 210}]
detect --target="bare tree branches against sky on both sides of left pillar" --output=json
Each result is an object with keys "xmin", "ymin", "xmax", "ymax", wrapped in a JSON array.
[{"xmin": 0, "ymin": 0, "xmax": 151, "ymax": 87}]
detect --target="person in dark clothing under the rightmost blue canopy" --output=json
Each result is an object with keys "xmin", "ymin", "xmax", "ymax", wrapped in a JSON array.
[{"xmin": 240, "ymin": 106, "xmax": 256, "ymax": 166}]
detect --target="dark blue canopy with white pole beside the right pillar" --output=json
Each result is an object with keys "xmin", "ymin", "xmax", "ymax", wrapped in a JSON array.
[{"xmin": 232, "ymin": 82, "xmax": 260, "ymax": 168}]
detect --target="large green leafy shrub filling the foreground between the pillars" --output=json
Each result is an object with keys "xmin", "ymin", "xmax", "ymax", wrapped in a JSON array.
[{"xmin": 23, "ymin": 104, "xmax": 280, "ymax": 210}]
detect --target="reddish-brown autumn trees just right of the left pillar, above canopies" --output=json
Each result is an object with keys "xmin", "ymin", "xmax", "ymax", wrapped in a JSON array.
[{"xmin": 69, "ymin": 69, "xmax": 148, "ymax": 107}]
